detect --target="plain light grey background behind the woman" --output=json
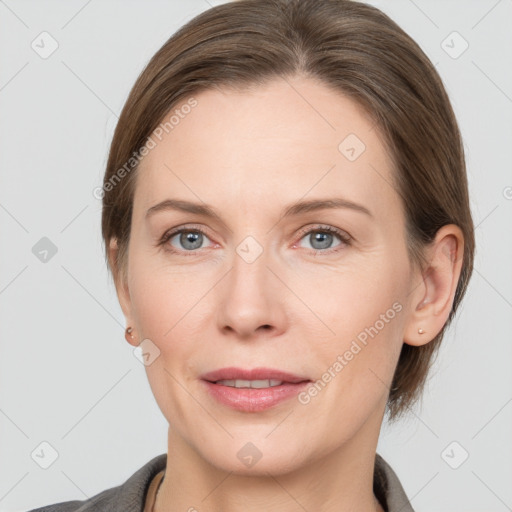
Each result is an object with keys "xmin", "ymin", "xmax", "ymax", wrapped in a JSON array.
[{"xmin": 0, "ymin": 0, "xmax": 512, "ymax": 512}]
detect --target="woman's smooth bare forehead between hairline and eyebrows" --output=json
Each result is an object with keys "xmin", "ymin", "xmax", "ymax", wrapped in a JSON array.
[{"xmin": 134, "ymin": 78, "xmax": 397, "ymax": 218}]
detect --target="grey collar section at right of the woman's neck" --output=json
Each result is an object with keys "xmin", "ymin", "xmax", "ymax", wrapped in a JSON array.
[{"xmin": 373, "ymin": 453, "xmax": 414, "ymax": 512}]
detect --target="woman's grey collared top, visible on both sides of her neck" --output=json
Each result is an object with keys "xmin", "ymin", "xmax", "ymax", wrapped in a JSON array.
[{"xmin": 29, "ymin": 453, "xmax": 414, "ymax": 512}]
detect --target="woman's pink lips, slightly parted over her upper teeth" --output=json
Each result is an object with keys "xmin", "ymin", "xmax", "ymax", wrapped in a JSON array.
[{"xmin": 201, "ymin": 367, "xmax": 311, "ymax": 412}]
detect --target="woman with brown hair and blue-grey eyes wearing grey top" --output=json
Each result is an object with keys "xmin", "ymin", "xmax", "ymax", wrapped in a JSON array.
[{"xmin": 30, "ymin": 0, "xmax": 474, "ymax": 512}]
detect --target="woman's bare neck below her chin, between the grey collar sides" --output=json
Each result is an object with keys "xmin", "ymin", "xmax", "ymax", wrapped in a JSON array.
[{"xmin": 153, "ymin": 408, "xmax": 384, "ymax": 512}]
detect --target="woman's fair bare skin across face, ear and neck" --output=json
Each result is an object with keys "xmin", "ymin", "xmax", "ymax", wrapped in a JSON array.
[{"xmin": 110, "ymin": 77, "xmax": 463, "ymax": 512}]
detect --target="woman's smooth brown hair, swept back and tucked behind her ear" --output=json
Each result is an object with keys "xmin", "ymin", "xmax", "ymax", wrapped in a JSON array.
[{"xmin": 102, "ymin": 0, "xmax": 475, "ymax": 420}]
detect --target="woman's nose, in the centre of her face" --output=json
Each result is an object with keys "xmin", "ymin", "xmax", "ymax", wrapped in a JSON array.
[{"xmin": 216, "ymin": 244, "xmax": 290, "ymax": 340}]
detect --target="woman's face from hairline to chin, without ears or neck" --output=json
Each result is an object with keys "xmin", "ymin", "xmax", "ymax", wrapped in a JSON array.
[{"xmin": 116, "ymin": 78, "xmax": 421, "ymax": 474}]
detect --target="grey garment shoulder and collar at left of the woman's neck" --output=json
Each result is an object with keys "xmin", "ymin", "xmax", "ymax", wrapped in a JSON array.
[{"xmin": 29, "ymin": 453, "xmax": 167, "ymax": 512}]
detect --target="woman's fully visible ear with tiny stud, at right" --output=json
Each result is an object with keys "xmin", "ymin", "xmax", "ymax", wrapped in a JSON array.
[{"xmin": 404, "ymin": 224, "xmax": 464, "ymax": 346}]
